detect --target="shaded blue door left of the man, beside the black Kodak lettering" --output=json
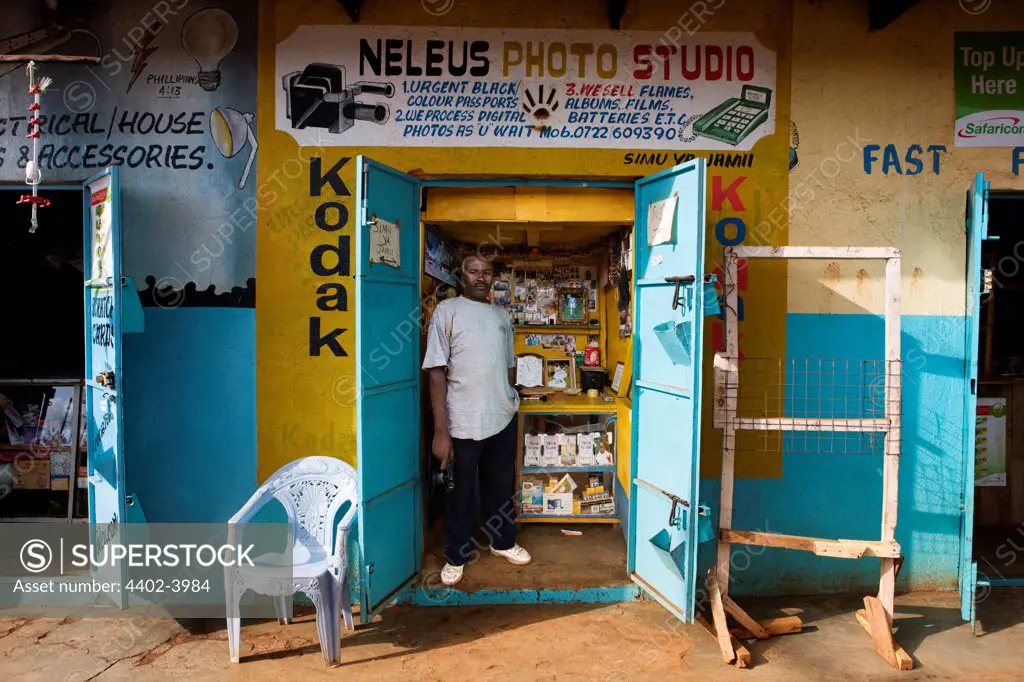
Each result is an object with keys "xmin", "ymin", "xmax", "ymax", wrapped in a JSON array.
[{"xmin": 355, "ymin": 157, "xmax": 422, "ymax": 623}]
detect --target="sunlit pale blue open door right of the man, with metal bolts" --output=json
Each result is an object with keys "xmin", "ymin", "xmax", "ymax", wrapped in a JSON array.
[{"xmin": 629, "ymin": 159, "xmax": 706, "ymax": 623}]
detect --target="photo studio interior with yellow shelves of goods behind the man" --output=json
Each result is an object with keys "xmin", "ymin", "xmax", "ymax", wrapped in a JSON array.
[{"xmin": 421, "ymin": 186, "xmax": 634, "ymax": 592}]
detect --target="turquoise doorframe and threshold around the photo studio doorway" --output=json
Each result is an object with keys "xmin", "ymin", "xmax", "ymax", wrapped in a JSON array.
[{"xmin": 405, "ymin": 175, "xmax": 645, "ymax": 606}]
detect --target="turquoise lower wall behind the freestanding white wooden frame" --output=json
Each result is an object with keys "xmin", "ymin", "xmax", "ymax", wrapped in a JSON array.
[{"xmin": 701, "ymin": 314, "xmax": 965, "ymax": 594}]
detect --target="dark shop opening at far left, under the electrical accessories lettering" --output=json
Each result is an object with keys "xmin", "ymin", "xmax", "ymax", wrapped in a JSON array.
[{"xmin": 0, "ymin": 184, "xmax": 88, "ymax": 521}]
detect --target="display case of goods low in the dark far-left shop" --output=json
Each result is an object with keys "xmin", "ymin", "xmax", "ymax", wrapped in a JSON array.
[{"xmin": 0, "ymin": 379, "xmax": 86, "ymax": 520}]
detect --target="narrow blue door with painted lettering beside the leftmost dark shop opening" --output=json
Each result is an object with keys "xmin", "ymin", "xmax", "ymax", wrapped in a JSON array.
[{"xmin": 83, "ymin": 166, "xmax": 129, "ymax": 608}]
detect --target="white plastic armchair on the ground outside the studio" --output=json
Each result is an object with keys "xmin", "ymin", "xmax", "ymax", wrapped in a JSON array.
[{"xmin": 224, "ymin": 457, "xmax": 359, "ymax": 666}]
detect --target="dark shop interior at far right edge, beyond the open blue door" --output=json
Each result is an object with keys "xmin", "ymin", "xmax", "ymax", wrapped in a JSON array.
[{"xmin": 974, "ymin": 190, "xmax": 1024, "ymax": 580}]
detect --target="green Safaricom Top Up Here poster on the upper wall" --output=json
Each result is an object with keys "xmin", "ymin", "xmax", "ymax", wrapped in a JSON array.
[{"xmin": 953, "ymin": 31, "xmax": 1024, "ymax": 146}]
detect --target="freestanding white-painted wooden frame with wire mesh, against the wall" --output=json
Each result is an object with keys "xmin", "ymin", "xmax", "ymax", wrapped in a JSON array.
[{"xmin": 714, "ymin": 246, "xmax": 902, "ymax": 614}]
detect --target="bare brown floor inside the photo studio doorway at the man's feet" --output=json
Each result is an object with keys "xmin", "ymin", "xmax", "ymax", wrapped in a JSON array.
[{"xmin": 423, "ymin": 523, "xmax": 630, "ymax": 592}]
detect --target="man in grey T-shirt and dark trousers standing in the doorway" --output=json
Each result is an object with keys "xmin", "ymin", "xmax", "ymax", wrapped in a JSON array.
[{"xmin": 423, "ymin": 255, "xmax": 530, "ymax": 585}]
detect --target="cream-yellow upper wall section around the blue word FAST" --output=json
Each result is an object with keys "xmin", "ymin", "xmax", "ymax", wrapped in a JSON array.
[{"xmin": 788, "ymin": 1, "xmax": 1024, "ymax": 315}]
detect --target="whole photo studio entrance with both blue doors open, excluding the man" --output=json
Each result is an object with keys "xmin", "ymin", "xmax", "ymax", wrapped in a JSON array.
[{"xmin": 355, "ymin": 157, "xmax": 706, "ymax": 621}]
